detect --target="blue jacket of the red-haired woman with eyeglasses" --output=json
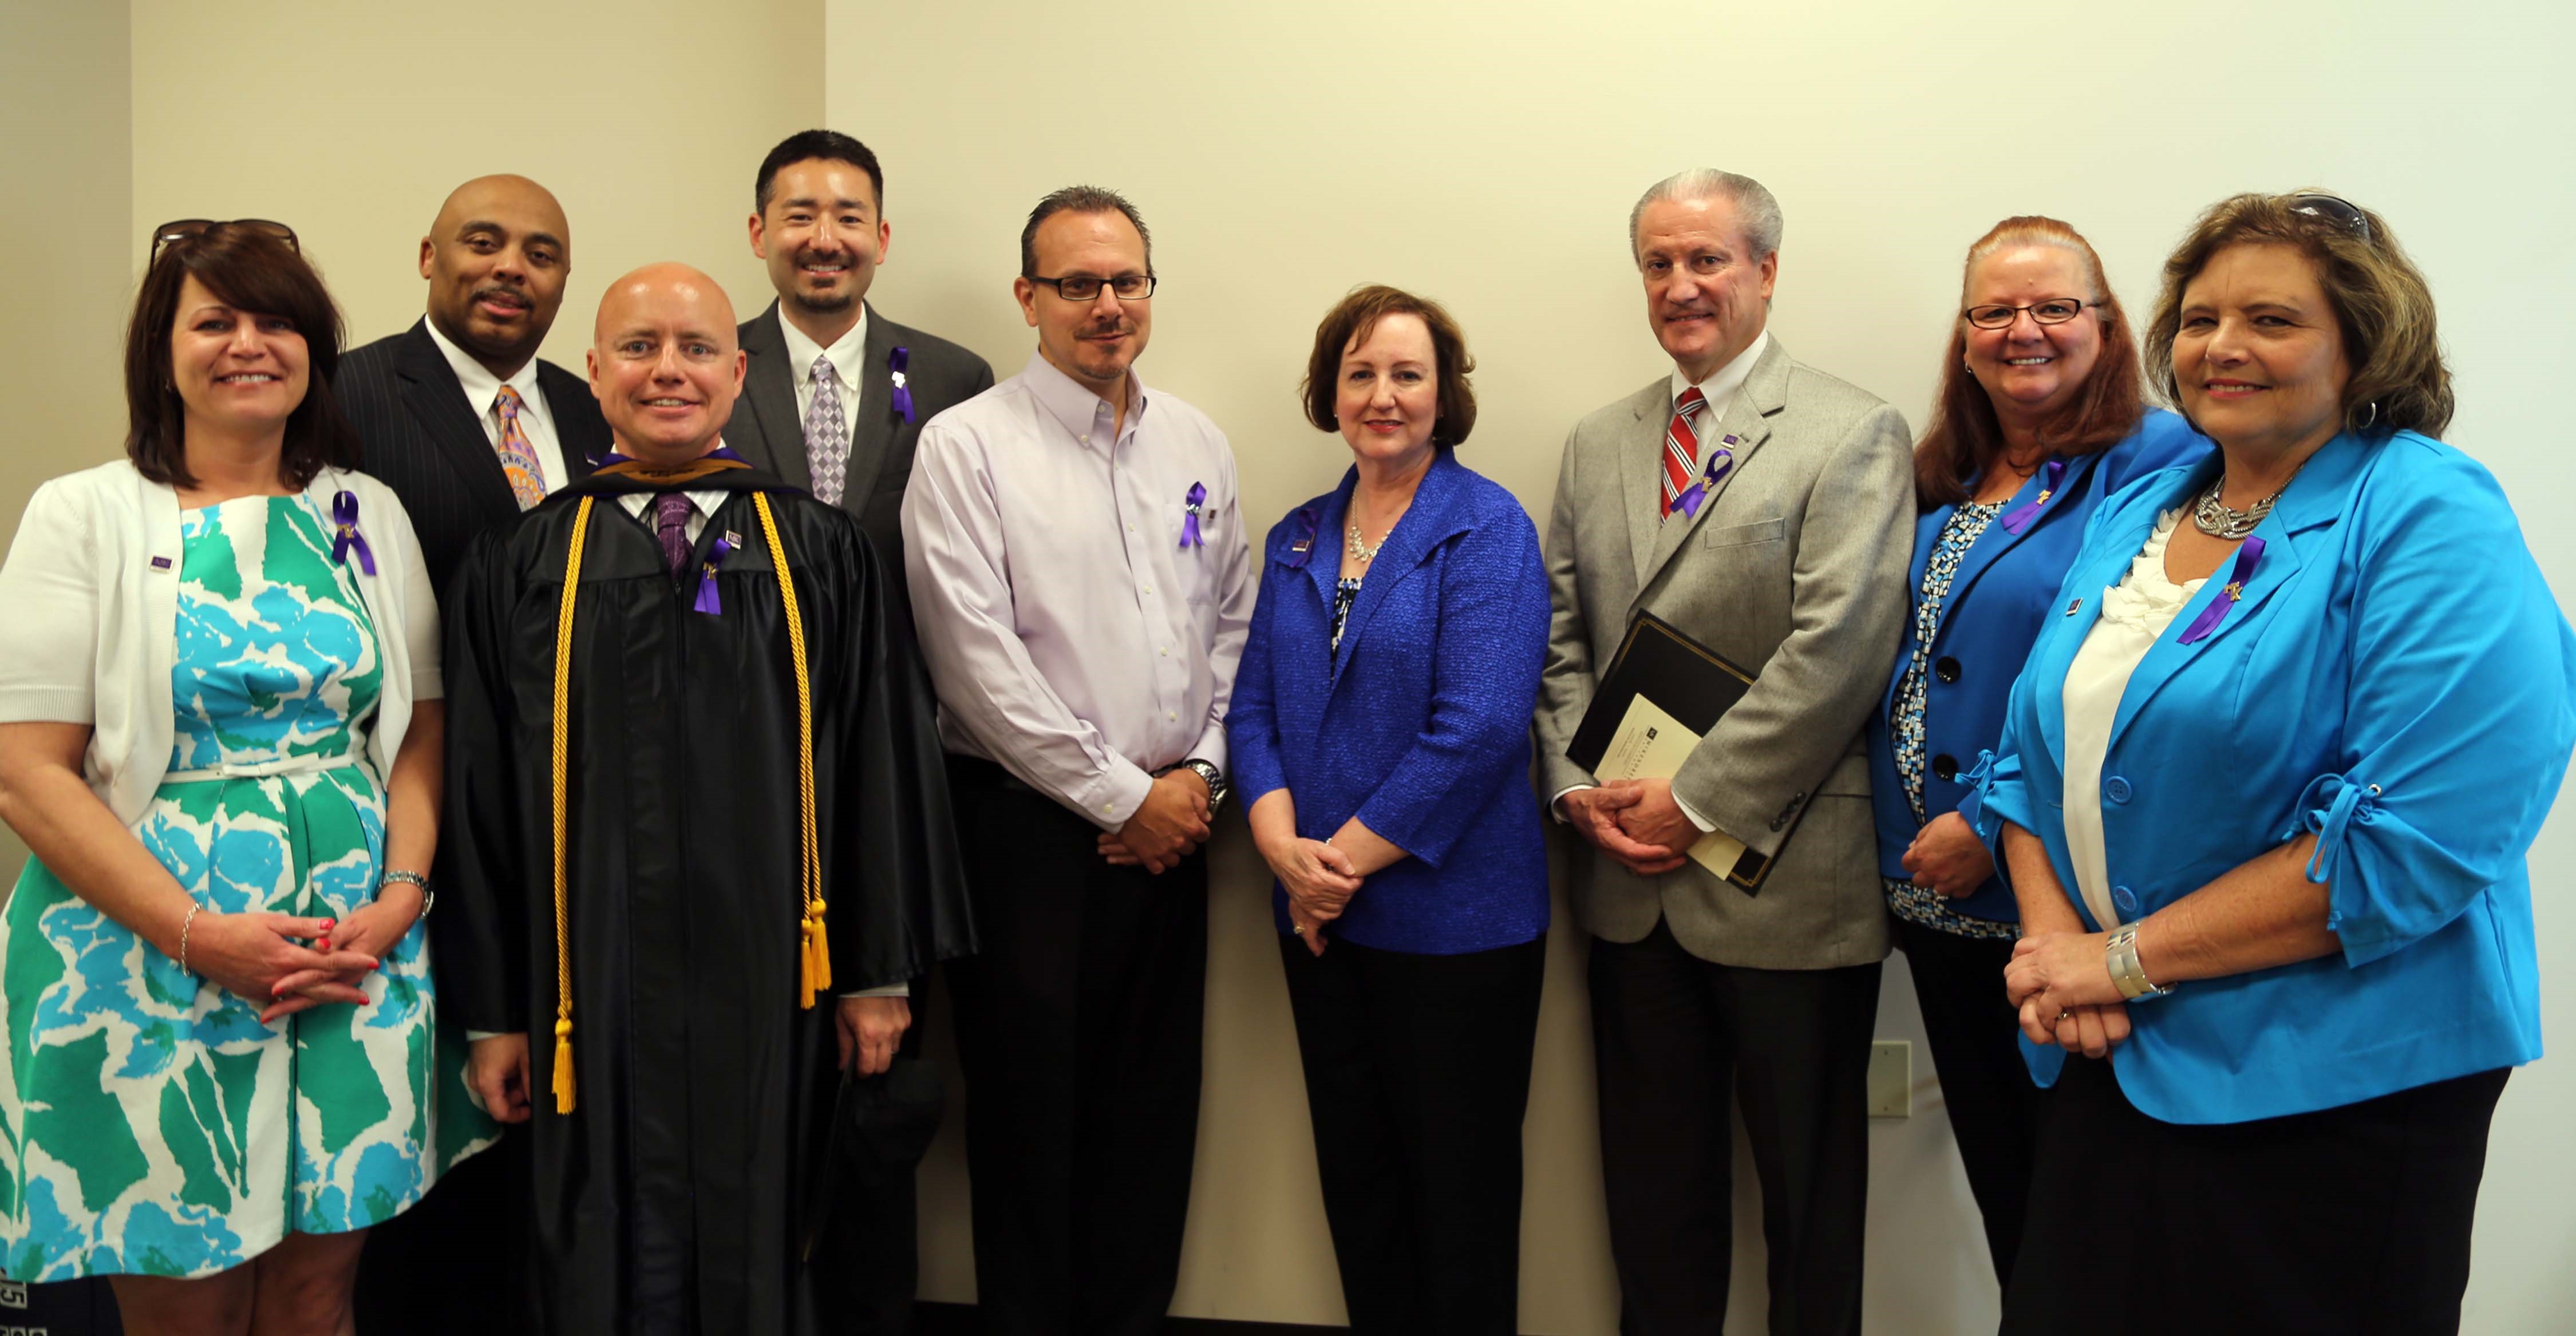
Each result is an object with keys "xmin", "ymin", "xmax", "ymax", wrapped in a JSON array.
[{"xmin": 1868, "ymin": 409, "xmax": 2210, "ymax": 924}]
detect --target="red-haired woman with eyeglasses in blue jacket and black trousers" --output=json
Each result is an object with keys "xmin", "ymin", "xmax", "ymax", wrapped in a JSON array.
[{"xmin": 1870, "ymin": 219, "xmax": 2210, "ymax": 1284}]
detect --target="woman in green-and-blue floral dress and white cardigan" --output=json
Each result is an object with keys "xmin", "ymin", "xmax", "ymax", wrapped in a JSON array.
[{"xmin": 0, "ymin": 222, "xmax": 492, "ymax": 1336}]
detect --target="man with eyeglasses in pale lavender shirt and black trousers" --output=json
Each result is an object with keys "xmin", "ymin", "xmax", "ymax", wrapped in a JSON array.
[{"xmin": 904, "ymin": 185, "xmax": 1255, "ymax": 1334}]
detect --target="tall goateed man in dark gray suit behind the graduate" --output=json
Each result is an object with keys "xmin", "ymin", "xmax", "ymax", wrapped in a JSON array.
[{"xmin": 724, "ymin": 129, "xmax": 999, "ymax": 1336}]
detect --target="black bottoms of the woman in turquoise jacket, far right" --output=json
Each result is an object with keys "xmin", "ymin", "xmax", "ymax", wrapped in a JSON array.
[{"xmin": 2004, "ymin": 1055, "xmax": 2509, "ymax": 1336}]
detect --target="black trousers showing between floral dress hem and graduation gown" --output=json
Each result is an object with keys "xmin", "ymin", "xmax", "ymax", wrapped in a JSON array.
[{"xmin": 353, "ymin": 1128, "xmax": 536, "ymax": 1336}]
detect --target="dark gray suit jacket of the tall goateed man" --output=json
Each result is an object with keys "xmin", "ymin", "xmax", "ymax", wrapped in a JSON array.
[{"xmin": 724, "ymin": 301, "xmax": 992, "ymax": 607}]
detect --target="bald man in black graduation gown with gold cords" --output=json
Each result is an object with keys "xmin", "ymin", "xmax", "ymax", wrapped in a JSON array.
[{"xmin": 430, "ymin": 265, "xmax": 971, "ymax": 1336}]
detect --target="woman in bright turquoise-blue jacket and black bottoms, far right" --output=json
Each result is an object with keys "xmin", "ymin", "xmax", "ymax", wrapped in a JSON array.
[{"xmin": 1973, "ymin": 196, "xmax": 2576, "ymax": 1334}]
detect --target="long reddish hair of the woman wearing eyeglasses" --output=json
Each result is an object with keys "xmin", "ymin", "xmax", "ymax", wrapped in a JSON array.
[{"xmin": 1914, "ymin": 216, "xmax": 2146, "ymax": 509}]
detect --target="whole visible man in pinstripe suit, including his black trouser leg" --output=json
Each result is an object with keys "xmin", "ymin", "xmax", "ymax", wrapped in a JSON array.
[{"xmin": 333, "ymin": 175, "xmax": 608, "ymax": 1336}]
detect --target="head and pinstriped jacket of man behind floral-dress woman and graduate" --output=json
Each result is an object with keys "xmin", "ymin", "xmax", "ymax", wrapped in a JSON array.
[{"xmin": 335, "ymin": 175, "xmax": 608, "ymax": 602}]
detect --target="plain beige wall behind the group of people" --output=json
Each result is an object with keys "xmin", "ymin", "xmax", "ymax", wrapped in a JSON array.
[{"xmin": 0, "ymin": 0, "xmax": 2576, "ymax": 1336}]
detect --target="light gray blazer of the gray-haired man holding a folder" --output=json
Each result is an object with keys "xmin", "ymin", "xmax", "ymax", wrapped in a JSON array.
[{"xmin": 1538, "ymin": 337, "xmax": 1914, "ymax": 970}]
